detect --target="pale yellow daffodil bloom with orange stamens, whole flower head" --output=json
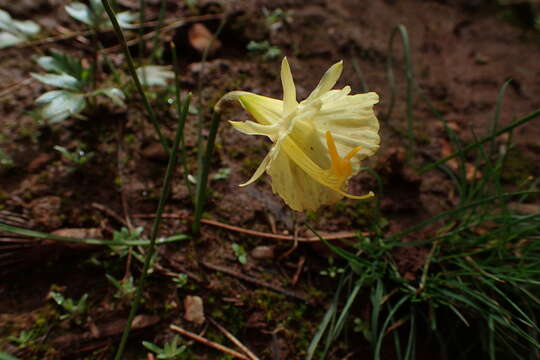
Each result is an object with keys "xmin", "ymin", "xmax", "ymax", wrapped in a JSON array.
[{"xmin": 216, "ymin": 58, "xmax": 380, "ymax": 211}]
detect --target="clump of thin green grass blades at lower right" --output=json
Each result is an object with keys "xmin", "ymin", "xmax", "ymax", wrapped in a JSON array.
[{"xmin": 306, "ymin": 23, "xmax": 540, "ymax": 360}]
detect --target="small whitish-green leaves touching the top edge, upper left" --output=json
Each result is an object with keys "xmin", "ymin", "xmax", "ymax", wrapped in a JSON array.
[{"xmin": 65, "ymin": 0, "xmax": 138, "ymax": 30}]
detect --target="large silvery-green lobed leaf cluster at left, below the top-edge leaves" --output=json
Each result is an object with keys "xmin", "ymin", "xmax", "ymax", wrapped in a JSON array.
[{"xmin": 31, "ymin": 50, "xmax": 125, "ymax": 124}]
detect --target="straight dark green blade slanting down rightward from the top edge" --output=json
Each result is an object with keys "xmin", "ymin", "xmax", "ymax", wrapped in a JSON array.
[{"xmin": 101, "ymin": 0, "xmax": 170, "ymax": 154}]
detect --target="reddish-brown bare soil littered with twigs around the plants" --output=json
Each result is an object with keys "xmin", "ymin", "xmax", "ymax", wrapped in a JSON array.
[{"xmin": 0, "ymin": 0, "xmax": 540, "ymax": 359}]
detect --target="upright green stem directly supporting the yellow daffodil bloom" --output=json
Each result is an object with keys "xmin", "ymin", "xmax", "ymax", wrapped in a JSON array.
[{"xmin": 192, "ymin": 111, "xmax": 220, "ymax": 234}]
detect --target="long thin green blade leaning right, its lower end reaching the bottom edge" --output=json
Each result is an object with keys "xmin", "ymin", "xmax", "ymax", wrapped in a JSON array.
[{"xmin": 112, "ymin": 95, "xmax": 187, "ymax": 360}]
